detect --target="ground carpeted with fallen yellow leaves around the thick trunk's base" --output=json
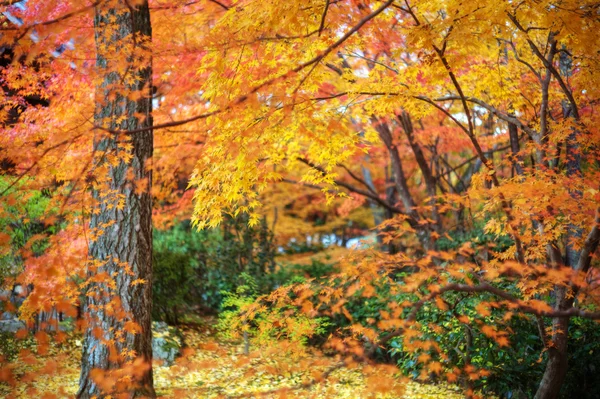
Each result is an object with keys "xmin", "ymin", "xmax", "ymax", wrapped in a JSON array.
[{"xmin": 0, "ymin": 328, "xmax": 463, "ymax": 399}]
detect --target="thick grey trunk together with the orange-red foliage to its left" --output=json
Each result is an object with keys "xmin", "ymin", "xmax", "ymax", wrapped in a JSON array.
[{"xmin": 2, "ymin": 1, "xmax": 155, "ymax": 398}]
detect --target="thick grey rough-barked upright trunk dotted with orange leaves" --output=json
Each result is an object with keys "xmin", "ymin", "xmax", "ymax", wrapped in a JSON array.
[{"xmin": 77, "ymin": 0, "xmax": 156, "ymax": 398}]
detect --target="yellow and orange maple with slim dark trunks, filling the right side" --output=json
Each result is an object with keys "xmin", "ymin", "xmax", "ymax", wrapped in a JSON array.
[{"xmin": 183, "ymin": 1, "xmax": 600, "ymax": 398}]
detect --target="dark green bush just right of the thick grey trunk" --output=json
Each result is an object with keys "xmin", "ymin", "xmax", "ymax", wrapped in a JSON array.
[{"xmin": 153, "ymin": 217, "xmax": 275, "ymax": 323}]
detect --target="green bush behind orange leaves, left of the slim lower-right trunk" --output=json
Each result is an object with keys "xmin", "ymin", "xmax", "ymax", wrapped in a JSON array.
[{"xmin": 332, "ymin": 278, "xmax": 543, "ymax": 397}]
